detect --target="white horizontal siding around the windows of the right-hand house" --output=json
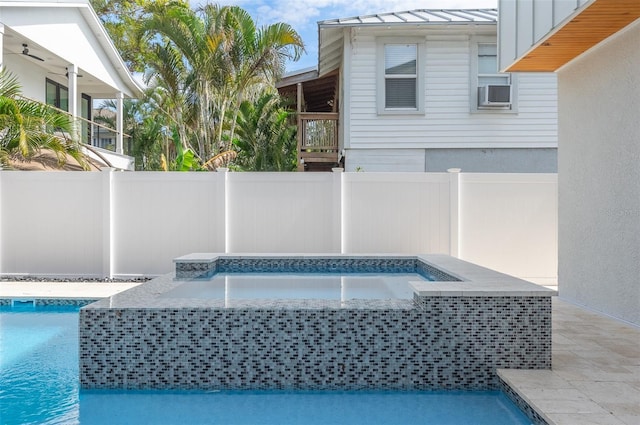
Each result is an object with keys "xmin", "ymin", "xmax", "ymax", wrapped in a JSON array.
[{"xmin": 344, "ymin": 29, "xmax": 557, "ymax": 149}]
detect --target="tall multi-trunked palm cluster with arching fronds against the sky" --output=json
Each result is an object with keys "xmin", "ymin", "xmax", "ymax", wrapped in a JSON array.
[{"xmin": 141, "ymin": 0, "xmax": 303, "ymax": 161}]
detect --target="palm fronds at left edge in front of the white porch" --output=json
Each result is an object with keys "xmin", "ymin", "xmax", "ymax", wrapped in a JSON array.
[{"xmin": 0, "ymin": 68, "xmax": 88, "ymax": 169}]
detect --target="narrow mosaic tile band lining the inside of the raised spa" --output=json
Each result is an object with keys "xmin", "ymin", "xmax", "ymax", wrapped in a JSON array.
[{"xmin": 176, "ymin": 257, "xmax": 460, "ymax": 281}]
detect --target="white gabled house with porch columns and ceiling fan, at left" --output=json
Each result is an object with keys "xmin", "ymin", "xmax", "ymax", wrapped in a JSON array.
[{"xmin": 0, "ymin": 0, "xmax": 142, "ymax": 169}]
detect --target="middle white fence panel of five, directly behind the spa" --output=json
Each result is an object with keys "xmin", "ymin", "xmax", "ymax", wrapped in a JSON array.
[{"xmin": 227, "ymin": 173, "xmax": 341, "ymax": 253}]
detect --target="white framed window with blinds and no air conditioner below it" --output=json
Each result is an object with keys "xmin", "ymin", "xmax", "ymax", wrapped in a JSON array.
[{"xmin": 376, "ymin": 37, "xmax": 424, "ymax": 114}]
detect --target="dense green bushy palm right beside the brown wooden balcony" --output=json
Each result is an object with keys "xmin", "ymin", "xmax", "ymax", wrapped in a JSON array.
[{"xmin": 233, "ymin": 94, "xmax": 297, "ymax": 171}]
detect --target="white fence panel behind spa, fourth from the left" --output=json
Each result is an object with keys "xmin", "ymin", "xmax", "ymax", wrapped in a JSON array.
[{"xmin": 343, "ymin": 173, "xmax": 451, "ymax": 254}]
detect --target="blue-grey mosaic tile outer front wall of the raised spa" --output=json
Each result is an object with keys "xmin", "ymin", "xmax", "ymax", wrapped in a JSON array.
[{"xmin": 80, "ymin": 297, "xmax": 551, "ymax": 390}]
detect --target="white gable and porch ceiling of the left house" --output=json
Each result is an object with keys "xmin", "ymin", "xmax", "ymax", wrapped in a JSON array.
[{"xmin": 0, "ymin": 0, "xmax": 142, "ymax": 99}]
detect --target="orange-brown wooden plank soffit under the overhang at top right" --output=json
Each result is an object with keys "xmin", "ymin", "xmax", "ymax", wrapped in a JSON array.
[{"xmin": 506, "ymin": 0, "xmax": 640, "ymax": 72}]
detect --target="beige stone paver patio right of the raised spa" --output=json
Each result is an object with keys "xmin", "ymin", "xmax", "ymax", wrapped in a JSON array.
[{"xmin": 499, "ymin": 298, "xmax": 640, "ymax": 425}]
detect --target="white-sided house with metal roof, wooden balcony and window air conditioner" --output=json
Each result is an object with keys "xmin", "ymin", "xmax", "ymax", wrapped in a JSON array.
[{"xmin": 278, "ymin": 9, "xmax": 557, "ymax": 172}]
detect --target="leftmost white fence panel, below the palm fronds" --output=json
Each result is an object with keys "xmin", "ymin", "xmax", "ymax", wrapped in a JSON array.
[{"xmin": 0, "ymin": 171, "xmax": 106, "ymax": 277}]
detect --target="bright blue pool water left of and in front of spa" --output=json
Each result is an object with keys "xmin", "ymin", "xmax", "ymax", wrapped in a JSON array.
[{"xmin": 0, "ymin": 307, "xmax": 530, "ymax": 425}]
